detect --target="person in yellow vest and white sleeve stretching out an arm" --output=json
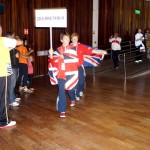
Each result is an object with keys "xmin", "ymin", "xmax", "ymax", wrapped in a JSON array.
[{"xmin": 0, "ymin": 26, "xmax": 22, "ymax": 128}]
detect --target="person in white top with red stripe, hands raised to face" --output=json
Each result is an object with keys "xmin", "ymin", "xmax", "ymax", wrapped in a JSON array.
[{"xmin": 109, "ymin": 33, "xmax": 122, "ymax": 69}]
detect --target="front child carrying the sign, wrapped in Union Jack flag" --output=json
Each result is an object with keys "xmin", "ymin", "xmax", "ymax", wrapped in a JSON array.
[{"xmin": 49, "ymin": 33, "xmax": 78, "ymax": 118}]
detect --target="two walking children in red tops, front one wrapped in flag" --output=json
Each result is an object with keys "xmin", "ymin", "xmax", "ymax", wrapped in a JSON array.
[{"xmin": 49, "ymin": 33, "xmax": 107, "ymax": 118}]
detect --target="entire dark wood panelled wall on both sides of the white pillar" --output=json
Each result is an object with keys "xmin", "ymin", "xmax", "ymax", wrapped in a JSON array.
[{"xmin": 0, "ymin": 0, "xmax": 150, "ymax": 76}]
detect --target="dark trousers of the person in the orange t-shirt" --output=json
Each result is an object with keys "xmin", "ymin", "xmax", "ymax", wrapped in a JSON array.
[{"xmin": 18, "ymin": 63, "xmax": 28, "ymax": 87}]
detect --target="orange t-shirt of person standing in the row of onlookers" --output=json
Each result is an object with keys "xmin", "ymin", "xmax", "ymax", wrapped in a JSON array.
[{"xmin": 17, "ymin": 45, "xmax": 28, "ymax": 64}]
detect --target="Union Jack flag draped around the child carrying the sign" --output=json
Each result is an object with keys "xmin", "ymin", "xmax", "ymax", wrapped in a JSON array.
[{"xmin": 48, "ymin": 46, "xmax": 78, "ymax": 90}]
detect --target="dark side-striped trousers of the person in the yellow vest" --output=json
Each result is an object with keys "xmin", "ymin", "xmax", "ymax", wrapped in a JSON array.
[{"xmin": 0, "ymin": 76, "xmax": 10, "ymax": 126}]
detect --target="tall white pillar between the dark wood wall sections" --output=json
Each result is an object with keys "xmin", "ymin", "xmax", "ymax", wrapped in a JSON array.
[{"xmin": 92, "ymin": 0, "xmax": 99, "ymax": 47}]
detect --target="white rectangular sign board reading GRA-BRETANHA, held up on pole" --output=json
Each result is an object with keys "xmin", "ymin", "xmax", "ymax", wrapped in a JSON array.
[{"xmin": 34, "ymin": 8, "xmax": 67, "ymax": 28}]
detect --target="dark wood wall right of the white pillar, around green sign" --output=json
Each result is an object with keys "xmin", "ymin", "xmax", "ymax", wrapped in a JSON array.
[{"xmin": 99, "ymin": 0, "xmax": 150, "ymax": 45}]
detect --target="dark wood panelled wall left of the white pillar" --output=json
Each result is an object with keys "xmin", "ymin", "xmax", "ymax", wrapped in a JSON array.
[{"xmin": 0, "ymin": 0, "xmax": 93, "ymax": 76}]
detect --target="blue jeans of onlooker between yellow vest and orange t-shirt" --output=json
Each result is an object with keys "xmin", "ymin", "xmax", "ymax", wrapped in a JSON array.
[{"xmin": 9, "ymin": 68, "xmax": 18, "ymax": 104}]
